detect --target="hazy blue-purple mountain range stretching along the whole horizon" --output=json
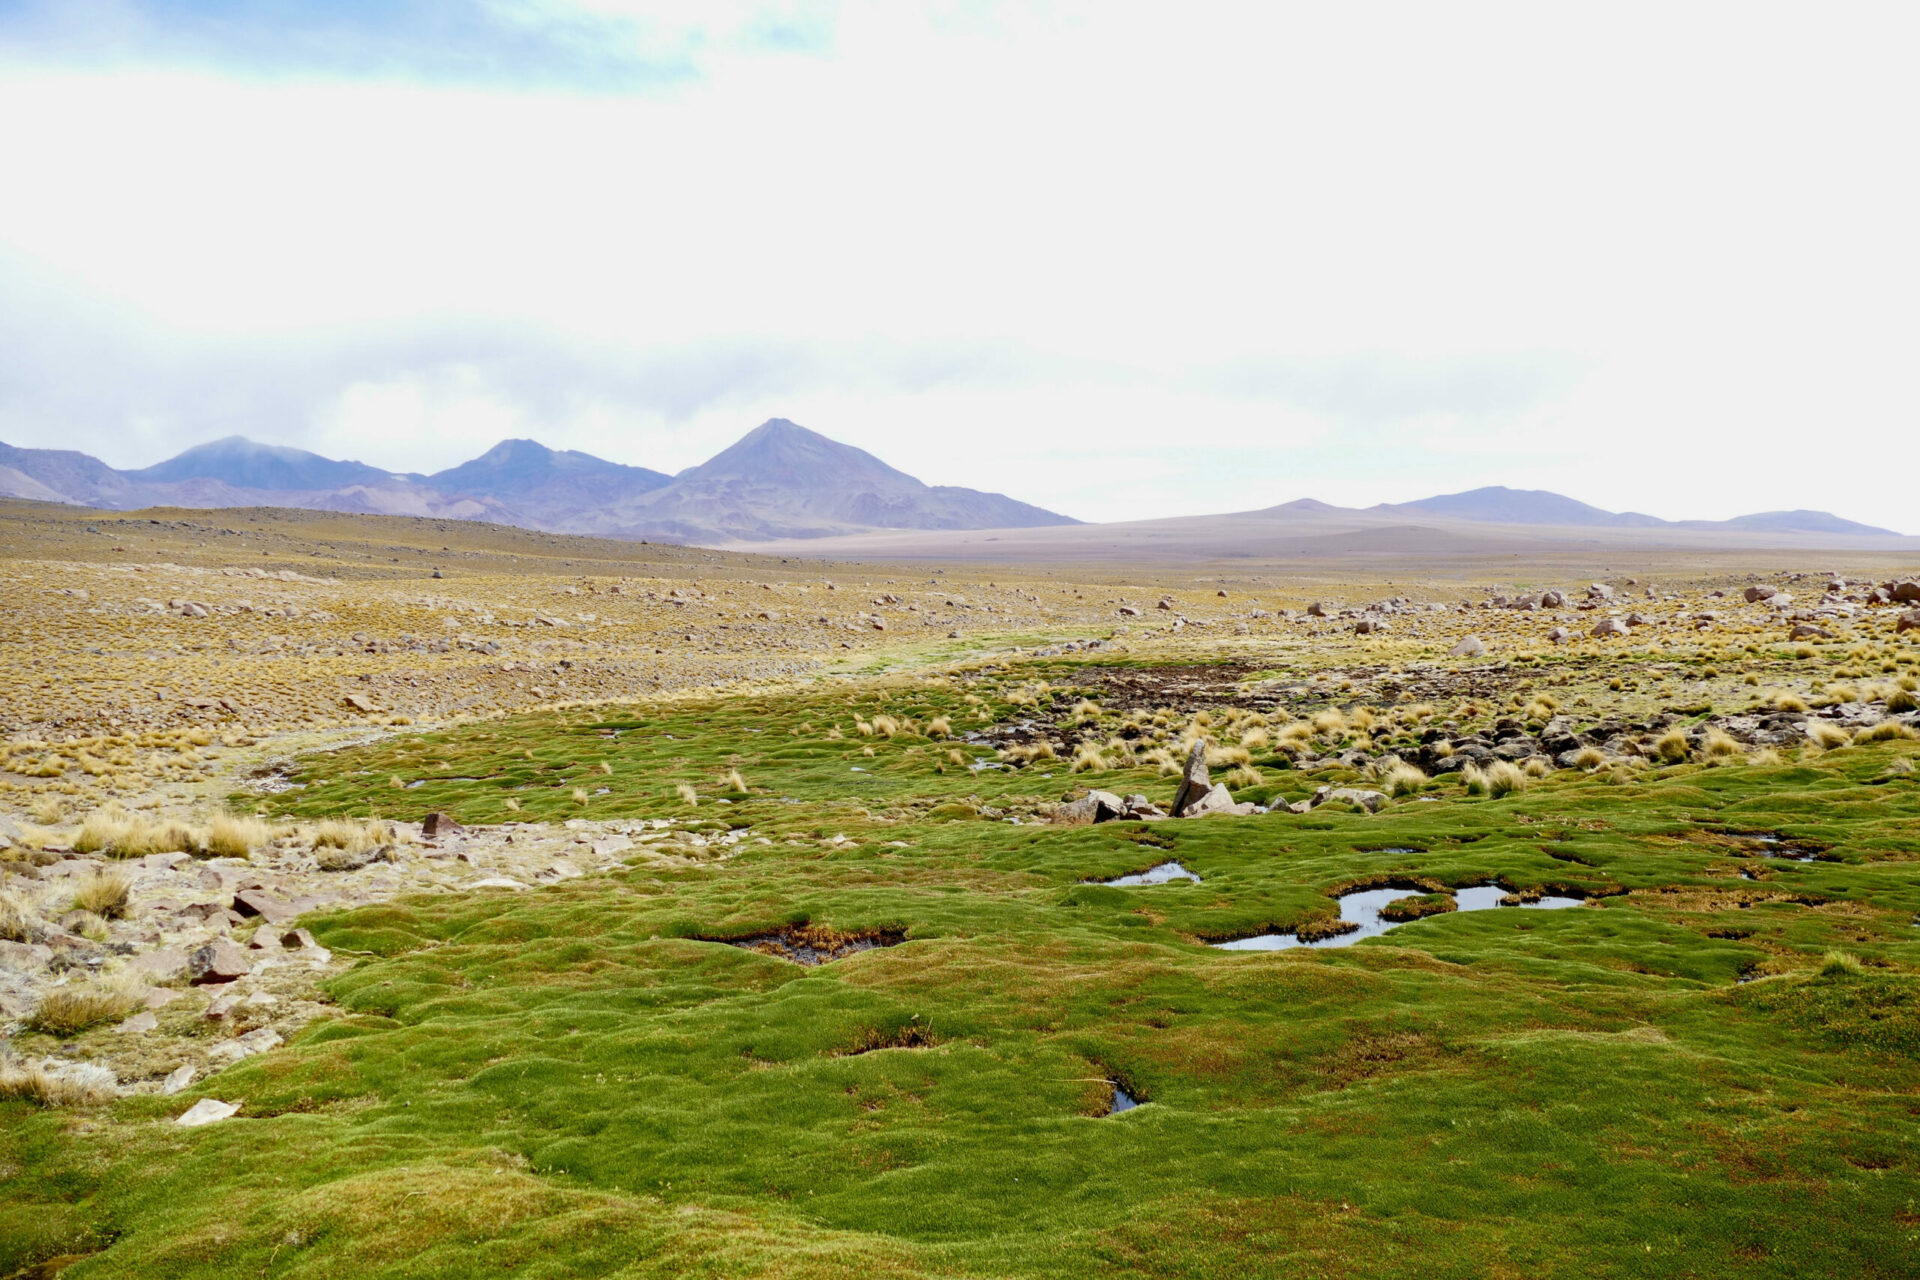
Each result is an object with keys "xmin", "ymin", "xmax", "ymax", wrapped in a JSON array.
[{"xmin": 0, "ymin": 418, "xmax": 1899, "ymax": 547}]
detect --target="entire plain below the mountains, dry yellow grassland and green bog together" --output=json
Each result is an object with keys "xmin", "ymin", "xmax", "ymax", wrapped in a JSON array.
[{"xmin": 0, "ymin": 503, "xmax": 1920, "ymax": 1280}]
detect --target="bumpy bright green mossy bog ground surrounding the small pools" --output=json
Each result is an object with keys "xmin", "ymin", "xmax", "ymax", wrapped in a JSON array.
[{"xmin": 0, "ymin": 660, "xmax": 1920, "ymax": 1280}]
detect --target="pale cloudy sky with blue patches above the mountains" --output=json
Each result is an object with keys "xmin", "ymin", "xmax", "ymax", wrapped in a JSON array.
[{"xmin": 0, "ymin": 0, "xmax": 1920, "ymax": 533}]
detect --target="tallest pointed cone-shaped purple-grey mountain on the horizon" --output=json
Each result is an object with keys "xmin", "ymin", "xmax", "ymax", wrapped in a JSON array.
[{"xmin": 591, "ymin": 418, "xmax": 1079, "ymax": 541}]
